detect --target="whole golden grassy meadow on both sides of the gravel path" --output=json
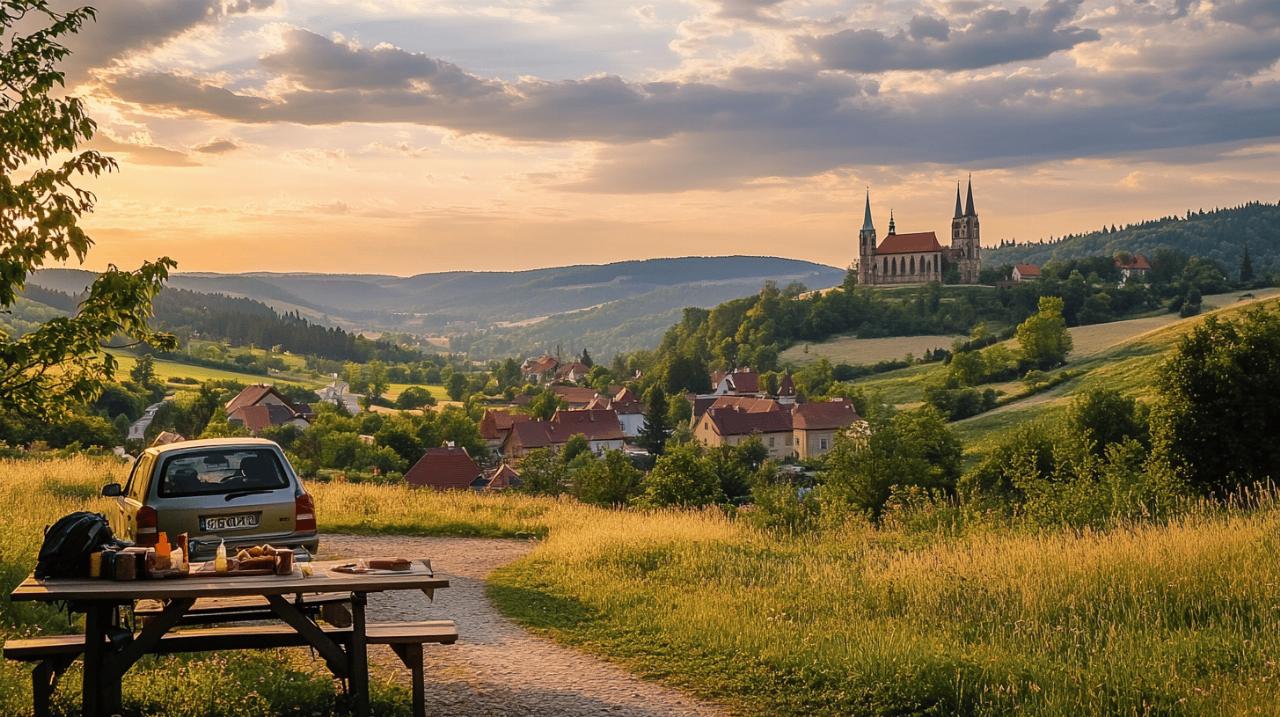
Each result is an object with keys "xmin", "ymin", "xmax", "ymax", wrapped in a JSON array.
[{"xmin": 0, "ymin": 458, "xmax": 1280, "ymax": 714}]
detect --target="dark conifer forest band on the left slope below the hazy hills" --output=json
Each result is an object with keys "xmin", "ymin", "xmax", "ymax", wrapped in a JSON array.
[{"xmin": 23, "ymin": 284, "xmax": 422, "ymax": 362}]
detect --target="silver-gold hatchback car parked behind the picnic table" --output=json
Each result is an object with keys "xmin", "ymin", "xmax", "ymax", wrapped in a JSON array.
[{"xmin": 102, "ymin": 438, "xmax": 320, "ymax": 561}]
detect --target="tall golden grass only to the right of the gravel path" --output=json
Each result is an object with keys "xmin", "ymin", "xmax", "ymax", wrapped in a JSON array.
[{"xmin": 492, "ymin": 507, "xmax": 1280, "ymax": 716}]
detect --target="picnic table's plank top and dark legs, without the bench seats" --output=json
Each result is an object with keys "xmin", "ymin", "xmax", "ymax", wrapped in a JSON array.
[{"xmin": 6, "ymin": 561, "xmax": 457, "ymax": 717}]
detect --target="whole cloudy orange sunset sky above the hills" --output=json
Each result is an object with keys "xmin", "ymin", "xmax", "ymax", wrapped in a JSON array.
[{"xmin": 27, "ymin": 0, "xmax": 1280, "ymax": 275}]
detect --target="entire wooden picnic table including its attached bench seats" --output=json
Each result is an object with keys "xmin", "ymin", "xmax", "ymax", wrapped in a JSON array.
[{"xmin": 4, "ymin": 561, "xmax": 458, "ymax": 717}]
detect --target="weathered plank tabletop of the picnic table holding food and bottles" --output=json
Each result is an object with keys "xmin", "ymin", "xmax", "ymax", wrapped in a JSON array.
[{"xmin": 9, "ymin": 560, "xmax": 449, "ymax": 602}]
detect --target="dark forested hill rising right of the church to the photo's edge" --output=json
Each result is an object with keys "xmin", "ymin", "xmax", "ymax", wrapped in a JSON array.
[{"xmin": 982, "ymin": 202, "xmax": 1280, "ymax": 277}]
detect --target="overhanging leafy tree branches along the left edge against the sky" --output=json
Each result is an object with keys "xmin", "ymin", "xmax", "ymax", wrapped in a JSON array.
[{"xmin": 0, "ymin": 0, "xmax": 177, "ymax": 417}]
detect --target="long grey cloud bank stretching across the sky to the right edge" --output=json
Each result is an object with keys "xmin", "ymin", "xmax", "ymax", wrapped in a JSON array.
[{"xmin": 97, "ymin": 14, "xmax": 1280, "ymax": 192}]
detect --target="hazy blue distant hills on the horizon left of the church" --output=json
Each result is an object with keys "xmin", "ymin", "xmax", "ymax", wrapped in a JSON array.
[{"xmin": 33, "ymin": 256, "xmax": 845, "ymax": 359}]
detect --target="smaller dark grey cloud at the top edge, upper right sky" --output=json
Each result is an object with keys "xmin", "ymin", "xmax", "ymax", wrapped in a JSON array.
[{"xmin": 799, "ymin": 0, "xmax": 1101, "ymax": 73}]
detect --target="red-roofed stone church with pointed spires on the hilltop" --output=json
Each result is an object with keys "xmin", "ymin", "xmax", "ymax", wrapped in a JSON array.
[{"xmin": 858, "ymin": 178, "xmax": 982, "ymax": 286}]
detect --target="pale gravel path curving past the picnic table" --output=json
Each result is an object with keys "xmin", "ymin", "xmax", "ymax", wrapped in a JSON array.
[{"xmin": 319, "ymin": 535, "xmax": 722, "ymax": 717}]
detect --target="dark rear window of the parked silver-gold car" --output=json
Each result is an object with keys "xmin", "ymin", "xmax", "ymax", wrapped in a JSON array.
[{"xmin": 160, "ymin": 448, "xmax": 289, "ymax": 498}]
